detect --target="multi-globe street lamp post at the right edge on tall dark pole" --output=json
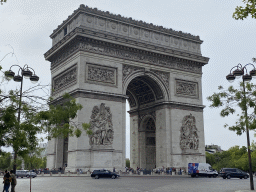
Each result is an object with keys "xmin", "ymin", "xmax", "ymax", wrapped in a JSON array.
[{"xmin": 226, "ymin": 63, "xmax": 256, "ymax": 190}]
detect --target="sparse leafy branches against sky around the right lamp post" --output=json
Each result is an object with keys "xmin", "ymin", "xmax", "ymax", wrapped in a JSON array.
[{"xmin": 207, "ymin": 82, "xmax": 256, "ymax": 135}]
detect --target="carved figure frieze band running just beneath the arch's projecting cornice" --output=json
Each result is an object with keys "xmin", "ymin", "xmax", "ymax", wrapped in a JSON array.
[{"xmin": 51, "ymin": 39, "xmax": 202, "ymax": 73}]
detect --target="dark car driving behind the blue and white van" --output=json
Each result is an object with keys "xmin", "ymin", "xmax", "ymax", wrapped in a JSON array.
[{"xmin": 219, "ymin": 168, "xmax": 249, "ymax": 179}]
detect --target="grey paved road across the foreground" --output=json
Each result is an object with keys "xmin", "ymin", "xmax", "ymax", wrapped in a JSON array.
[{"xmin": 7, "ymin": 176, "xmax": 253, "ymax": 192}]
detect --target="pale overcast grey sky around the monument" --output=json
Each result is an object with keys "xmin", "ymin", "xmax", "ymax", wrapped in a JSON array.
[{"xmin": 0, "ymin": 0, "xmax": 256, "ymax": 157}]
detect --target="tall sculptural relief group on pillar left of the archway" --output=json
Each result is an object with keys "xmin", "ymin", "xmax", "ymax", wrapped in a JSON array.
[{"xmin": 89, "ymin": 103, "xmax": 114, "ymax": 146}]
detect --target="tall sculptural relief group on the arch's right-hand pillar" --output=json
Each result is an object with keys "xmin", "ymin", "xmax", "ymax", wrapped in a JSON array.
[{"xmin": 180, "ymin": 114, "xmax": 199, "ymax": 150}]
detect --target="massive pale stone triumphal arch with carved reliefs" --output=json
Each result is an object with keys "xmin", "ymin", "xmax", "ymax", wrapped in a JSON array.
[{"xmin": 45, "ymin": 5, "xmax": 209, "ymax": 171}]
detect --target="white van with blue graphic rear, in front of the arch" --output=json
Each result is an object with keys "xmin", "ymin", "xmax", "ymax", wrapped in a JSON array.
[{"xmin": 188, "ymin": 163, "xmax": 218, "ymax": 178}]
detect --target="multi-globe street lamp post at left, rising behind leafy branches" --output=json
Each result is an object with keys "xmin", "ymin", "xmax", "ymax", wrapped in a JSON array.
[{"xmin": 5, "ymin": 64, "xmax": 39, "ymax": 174}]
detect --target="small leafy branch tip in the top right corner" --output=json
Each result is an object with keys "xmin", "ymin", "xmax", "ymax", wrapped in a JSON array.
[{"xmin": 233, "ymin": 0, "xmax": 256, "ymax": 20}]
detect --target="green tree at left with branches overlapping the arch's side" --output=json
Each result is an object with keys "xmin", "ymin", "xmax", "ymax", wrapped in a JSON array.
[{"xmin": 0, "ymin": 89, "xmax": 91, "ymax": 171}]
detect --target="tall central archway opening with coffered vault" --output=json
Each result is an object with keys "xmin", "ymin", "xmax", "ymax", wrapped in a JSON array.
[{"xmin": 126, "ymin": 76, "xmax": 164, "ymax": 170}]
